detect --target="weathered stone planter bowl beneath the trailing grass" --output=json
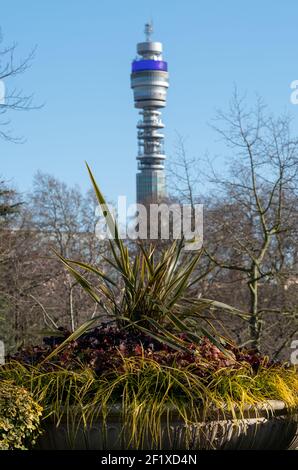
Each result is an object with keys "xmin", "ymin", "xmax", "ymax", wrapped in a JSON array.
[{"xmin": 38, "ymin": 400, "xmax": 298, "ymax": 450}]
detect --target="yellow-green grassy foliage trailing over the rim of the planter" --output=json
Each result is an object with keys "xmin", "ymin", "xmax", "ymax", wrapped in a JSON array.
[{"xmin": 1, "ymin": 355, "xmax": 298, "ymax": 448}]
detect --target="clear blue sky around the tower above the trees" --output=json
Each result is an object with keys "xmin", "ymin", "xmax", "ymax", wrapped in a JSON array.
[{"xmin": 0, "ymin": 0, "xmax": 298, "ymax": 204}]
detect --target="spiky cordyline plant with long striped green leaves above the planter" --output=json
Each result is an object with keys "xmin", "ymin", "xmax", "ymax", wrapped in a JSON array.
[{"xmin": 47, "ymin": 165, "xmax": 247, "ymax": 360}]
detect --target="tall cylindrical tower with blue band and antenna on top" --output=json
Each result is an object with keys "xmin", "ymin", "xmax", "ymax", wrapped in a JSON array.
[{"xmin": 131, "ymin": 23, "xmax": 169, "ymax": 204}]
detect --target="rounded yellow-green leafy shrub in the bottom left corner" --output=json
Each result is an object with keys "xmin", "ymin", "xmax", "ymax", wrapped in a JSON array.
[{"xmin": 0, "ymin": 380, "xmax": 42, "ymax": 450}]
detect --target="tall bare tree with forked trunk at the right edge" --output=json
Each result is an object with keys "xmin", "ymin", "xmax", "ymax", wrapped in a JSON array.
[{"xmin": 205, "ymin": 92, "xmax": 298, "ymax": 350}]
